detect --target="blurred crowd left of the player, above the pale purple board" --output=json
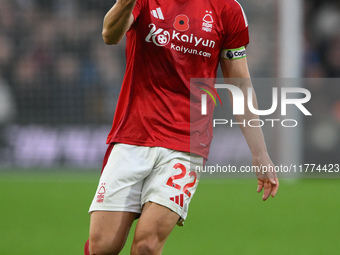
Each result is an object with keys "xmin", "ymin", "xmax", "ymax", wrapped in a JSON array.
[{"xmin": 0, "ymin": 0, "xmax": 125, "ymax": 124}]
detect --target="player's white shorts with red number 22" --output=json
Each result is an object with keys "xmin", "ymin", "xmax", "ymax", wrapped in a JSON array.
[{"xmin": 89, "ymin": 143, "xmax": 203, "ymax": 225}]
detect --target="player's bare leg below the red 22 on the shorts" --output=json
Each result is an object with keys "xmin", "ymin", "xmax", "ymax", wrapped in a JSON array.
[{"xmin": 131, "ymin": 202, "xmax": 179, "ymax": 255}]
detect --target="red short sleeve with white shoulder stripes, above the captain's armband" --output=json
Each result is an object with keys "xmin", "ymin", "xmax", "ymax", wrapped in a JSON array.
[{"xmin": 222, "ymin": 0, "xmax": 249, "ymax": 50}]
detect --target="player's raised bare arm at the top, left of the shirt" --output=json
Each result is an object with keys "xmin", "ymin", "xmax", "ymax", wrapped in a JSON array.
[{"xmin": 102, "ymin": 0, "xmax": 136, "ymax": 44}]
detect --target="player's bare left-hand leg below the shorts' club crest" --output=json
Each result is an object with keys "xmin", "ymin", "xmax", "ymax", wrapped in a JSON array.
[{"xmin": 90, "ymin": 211, "xmax": 139, "ymax": 254}]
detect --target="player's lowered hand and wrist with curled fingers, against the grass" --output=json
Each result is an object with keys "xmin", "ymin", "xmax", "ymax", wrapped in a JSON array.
[{"xmin": 253, "ymin": 154, "xmax": 279, "ymax": 201}]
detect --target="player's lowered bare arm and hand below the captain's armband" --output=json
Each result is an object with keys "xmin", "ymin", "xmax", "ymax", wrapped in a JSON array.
[{"xmin": 221, "ymin": 58, "xmax": 279, "ymax": 200}]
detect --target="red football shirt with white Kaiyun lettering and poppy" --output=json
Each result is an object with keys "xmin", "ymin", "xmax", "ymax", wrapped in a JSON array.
[{"xmin": 107, "ymin": 0, "xmax": 249, "ymax": 158}]
